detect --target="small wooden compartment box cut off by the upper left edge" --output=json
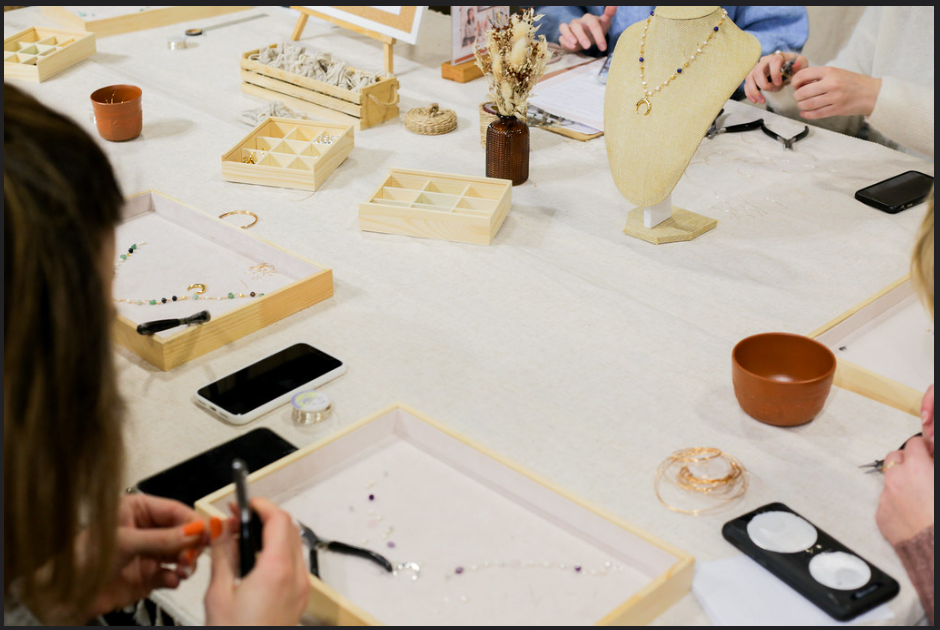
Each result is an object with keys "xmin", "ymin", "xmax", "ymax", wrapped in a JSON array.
[{"xmin": 3, "ymin": 27, "xmax": 95, "ymax": 83}]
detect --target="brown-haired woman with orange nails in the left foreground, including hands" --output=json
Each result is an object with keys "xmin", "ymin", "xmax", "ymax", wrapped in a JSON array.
[{"xmin": 3, "ymin": 84, "xmax": 309, "ymax": 625}]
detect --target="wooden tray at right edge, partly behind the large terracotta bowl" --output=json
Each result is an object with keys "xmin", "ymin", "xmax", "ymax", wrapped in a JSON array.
[{"xmin": 809, "ymin": 276, "xmax": 934, "ymax": 417}]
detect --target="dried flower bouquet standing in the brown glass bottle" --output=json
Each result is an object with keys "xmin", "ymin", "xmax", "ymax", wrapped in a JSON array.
[{"xmin": 473, "ymin": 8, "xmax": 552, "ymax": 121}]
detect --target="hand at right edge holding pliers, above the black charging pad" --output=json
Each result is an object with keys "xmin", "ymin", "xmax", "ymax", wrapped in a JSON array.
[{"xmin": 875, "ymin": 437, "xmax": 933, "ymax": 545}]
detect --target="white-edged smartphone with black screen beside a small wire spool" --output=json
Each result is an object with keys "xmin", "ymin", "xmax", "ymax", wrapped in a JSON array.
[{"xmin": 195, "ymin": 343, "xmax": 346, "ymax": 424}]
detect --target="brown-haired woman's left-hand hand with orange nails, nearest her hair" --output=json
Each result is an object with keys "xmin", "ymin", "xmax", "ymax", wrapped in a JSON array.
[{"xmin": 88, "ymin": 494, "xmax": 209, "ymax": 618}]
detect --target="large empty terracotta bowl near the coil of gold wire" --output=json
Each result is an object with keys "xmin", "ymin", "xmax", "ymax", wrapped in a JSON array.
[{"xmin": 731, "ymin": 333, "xmax": 836, "ymax": 427}]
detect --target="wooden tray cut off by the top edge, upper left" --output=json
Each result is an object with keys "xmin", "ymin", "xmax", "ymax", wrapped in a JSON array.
[{"xmin": 42, "ymin": 6, "xmax": 254, "ymax": 37}]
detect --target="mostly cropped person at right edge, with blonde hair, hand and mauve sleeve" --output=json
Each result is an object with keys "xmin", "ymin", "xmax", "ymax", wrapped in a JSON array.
[{"xmin": 875, "ymin": 193, "xmax": 934, "ymax": 624}]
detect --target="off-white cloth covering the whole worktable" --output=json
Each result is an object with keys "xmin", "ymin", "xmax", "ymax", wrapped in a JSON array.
[{"xmin": 4, "ymin": 7, "xmax": 933, "ymax": 625}]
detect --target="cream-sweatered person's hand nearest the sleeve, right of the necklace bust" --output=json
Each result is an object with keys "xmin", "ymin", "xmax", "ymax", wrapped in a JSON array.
[{"xmin": 790, "ymin": 66, "xmax": 881, "ymax": 120}]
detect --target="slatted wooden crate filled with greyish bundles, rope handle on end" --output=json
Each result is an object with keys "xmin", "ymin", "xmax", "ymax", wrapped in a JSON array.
[{"xmin": 241, "ymin": 43, "xmax": 399, "ymax": 130}]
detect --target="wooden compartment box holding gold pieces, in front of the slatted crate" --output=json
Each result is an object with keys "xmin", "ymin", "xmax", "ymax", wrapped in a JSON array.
[{"xmin": 222, "ymin": 117, "xmax": 354, "ymax": 190}]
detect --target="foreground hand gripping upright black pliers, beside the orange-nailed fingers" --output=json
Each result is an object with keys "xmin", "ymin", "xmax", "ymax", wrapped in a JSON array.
[{"xmin": 205, "ymin": 497, "xmax": 310, "ymax": 626}]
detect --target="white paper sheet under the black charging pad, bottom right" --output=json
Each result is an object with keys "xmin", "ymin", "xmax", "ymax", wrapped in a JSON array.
[{"xmin": 692, "ymin": 556, "xmax": 894, "ymax": 626}]
